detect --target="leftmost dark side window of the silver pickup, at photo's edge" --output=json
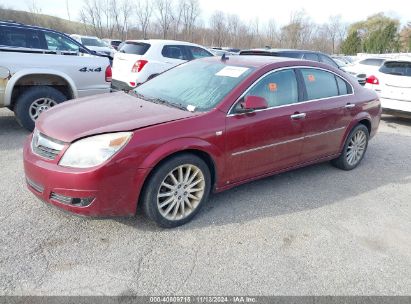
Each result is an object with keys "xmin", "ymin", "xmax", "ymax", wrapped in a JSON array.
[{"xmin": 0, "ymin": 27, "xmax": 42, "ymax": 49}]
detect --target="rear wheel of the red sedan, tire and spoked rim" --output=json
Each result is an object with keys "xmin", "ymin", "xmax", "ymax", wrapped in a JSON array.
[{"xmin": 331, "ymin": 124, "xmax": 370, "ymax": 171}]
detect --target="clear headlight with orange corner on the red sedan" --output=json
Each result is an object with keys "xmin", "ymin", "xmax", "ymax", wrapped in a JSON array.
[{"xmin": 59, "ymin": 132, "xmax": 133, "ymax": 168}]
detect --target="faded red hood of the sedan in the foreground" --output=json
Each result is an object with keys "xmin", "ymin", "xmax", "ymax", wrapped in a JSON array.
[{"xmin": 36, "ymin": 92, "xmax": 196, "ymax": 142}]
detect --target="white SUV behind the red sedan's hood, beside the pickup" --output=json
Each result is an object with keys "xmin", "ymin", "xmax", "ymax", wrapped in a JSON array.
[{"xmin": 112, "ymin": 39, "xmax": 213, "ymax": 91}]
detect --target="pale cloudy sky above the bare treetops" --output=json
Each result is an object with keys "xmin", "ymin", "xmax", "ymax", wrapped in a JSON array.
[{"xmin": 0, "ymin": 0, "xmax": 411, "ymax": 26}]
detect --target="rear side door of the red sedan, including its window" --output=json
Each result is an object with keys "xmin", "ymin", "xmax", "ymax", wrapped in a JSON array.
[{"xmin": 299, "ymin": 68, "xmax": 358, "ymax": 163}]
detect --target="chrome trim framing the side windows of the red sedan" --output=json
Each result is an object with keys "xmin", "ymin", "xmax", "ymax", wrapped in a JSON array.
[{"xmin": 226, "ymin": 66, "xmax": 355, "ymax": 117}]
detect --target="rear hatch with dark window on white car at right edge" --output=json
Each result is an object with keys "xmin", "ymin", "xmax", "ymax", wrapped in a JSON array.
[{"xmin": 378, "ymin": 61, "xmax": 411, "ymax": 101}]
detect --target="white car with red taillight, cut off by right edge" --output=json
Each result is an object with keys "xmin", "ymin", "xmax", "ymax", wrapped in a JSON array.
[{"xmin": 366, "ymin": 58, "xmax": 411, "ymax": 118}]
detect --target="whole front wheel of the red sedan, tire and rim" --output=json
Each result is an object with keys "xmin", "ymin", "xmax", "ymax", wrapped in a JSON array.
[{"xmin": 140, "ymin": 154, "xmax": 211, "ymax": 228}]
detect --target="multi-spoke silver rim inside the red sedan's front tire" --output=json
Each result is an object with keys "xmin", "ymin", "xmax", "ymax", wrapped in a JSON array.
[{"xmin": 157, "ymin": 164, "xmax": 205, "ymax": 221}]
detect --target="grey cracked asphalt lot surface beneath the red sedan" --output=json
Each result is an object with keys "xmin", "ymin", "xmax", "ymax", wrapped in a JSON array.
[{"xmin": 0, "ymin": 110, "xmax": 411, "ymax": 295}]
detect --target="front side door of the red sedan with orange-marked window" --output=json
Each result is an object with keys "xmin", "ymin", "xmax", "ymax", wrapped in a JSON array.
[{"xmin": 226, "ymin": 69, "xmax": 304, "ymax": 182}]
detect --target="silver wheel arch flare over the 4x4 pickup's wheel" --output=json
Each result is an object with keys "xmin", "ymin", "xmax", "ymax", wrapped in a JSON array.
[{"xmin": 4, "ymin": 69, "xmax": 78, "ymax": 107}]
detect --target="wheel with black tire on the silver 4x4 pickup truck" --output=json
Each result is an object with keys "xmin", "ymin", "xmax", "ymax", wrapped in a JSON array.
[{"xmin": 14, "ymin": 86, "xmax": 67, "ymax": 131}]
